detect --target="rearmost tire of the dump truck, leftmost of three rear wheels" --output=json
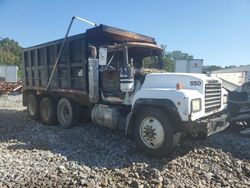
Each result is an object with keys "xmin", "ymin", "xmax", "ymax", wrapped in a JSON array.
[{"xmin": 27, "ymin": 94, "xmax": 39, "ymax": 120}]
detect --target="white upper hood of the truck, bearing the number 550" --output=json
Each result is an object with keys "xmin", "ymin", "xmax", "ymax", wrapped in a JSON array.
[{"xmin": 142, "ymin": 73, "xmax": 221, "ymax": 93}]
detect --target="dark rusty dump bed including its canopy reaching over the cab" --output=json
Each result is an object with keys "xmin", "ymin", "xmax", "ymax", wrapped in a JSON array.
[{"xmin": 22, "ymin": 25, "xmax": 155, "ymax": 94}]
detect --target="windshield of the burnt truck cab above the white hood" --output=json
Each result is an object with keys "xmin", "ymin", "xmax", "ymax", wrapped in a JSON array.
[{"xmin": 128, "ymin": 47, "xmax": 162, "ymax": 69}]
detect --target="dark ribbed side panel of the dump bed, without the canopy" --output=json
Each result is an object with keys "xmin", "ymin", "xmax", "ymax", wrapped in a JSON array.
[{"xmin": 23, "ymin": 34, "xmax": 88, "ymax": 94}]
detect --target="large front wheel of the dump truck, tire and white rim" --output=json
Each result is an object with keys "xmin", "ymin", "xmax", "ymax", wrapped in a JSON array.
[{"xmin": 134, "ymin": 107, "xmax": 174, "ymax": 157}]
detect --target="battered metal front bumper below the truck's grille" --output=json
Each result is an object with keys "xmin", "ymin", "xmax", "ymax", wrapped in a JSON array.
[{"xmin": 185, "ymin": 113, "xmax": 230, "ymax": 136}]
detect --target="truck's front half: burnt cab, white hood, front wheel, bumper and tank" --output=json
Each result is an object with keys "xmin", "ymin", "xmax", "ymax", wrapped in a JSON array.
[{"xmin": 92, "ymin": 42, "xmax": 228, "ymax": 156}]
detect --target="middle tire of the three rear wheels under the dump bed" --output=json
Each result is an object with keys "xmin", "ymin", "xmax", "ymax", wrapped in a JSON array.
[{"xmin": 39, "ymin": 97, "xmax": 57, "ymax": 125}]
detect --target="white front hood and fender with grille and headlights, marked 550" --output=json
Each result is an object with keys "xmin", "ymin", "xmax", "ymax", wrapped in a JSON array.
[{"xmin": 132, "ymin": 73, "xmax": 227, "ymax": 121}]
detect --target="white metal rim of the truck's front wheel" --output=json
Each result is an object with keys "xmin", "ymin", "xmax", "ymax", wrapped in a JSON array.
[{"xmin": 140, "ymin": 117, "xmax": 164, "ymax": 149}]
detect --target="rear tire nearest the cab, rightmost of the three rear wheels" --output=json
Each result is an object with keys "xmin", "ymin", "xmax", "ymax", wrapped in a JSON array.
[{"xmin": 57, "ymin": 98, "xmax": 79, "ymax": 128}]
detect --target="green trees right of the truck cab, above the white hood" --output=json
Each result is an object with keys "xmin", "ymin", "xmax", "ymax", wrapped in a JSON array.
[{"xmin": 161, "ymin": 45, "xmax": 194, "ymax": 72}]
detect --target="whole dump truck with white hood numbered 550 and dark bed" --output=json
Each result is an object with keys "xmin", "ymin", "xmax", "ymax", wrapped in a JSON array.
[{"xmin": 22, "ymin": 17, "xmax": 228, "ymax": 157}]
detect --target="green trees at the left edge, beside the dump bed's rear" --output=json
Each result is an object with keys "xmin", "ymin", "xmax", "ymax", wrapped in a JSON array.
[{"xmin": 0, "ymin": 38, "xmax": 22, "ymax": 69}]
